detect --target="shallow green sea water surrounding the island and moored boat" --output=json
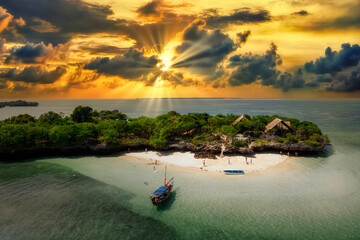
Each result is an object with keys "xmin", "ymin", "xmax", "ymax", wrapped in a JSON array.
[{"xmin": 0, "ymin": 99, "xmax": 360, "ymax": 239}]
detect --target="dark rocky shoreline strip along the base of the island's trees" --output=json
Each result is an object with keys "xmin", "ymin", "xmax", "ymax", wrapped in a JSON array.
[{"xmin": 1, "ymin": 141, "xmax": 327, "ymax": 161}]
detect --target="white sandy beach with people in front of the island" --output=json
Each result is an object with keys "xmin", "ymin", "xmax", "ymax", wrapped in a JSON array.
[{"xmin": 125, "ymin": 151, "xmax": 288, "ymax": 173}]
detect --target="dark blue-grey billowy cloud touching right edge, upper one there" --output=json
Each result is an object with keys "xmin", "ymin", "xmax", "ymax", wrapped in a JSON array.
[{"xmin": 304, "ymin": 43, "xmax": 360, "ymax": 74}]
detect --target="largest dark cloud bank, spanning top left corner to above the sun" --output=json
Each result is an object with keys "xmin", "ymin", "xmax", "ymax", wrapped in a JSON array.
[{"xmin": 2, "ymin": 0, "xmax": 194, "ymax": 51}]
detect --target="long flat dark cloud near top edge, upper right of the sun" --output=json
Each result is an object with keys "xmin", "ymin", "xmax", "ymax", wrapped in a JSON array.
[{"xmin": 205, "ymin": 8, "xmax": 271, "ymax": 28}]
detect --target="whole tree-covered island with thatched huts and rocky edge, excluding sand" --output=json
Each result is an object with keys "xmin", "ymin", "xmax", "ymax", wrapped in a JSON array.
[{"xmin": 0, "ymin": 106, "xmax": 330, "ymax": 161}]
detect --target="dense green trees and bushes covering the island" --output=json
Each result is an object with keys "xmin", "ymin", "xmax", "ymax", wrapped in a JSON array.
[{"xmin": 0, "ymin": 106, "xmax": 329, "ymax": 154}]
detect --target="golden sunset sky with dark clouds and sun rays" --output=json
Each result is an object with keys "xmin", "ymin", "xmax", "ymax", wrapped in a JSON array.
[{"xmin": 0, "ymin": 0, "xmax": 360, "ymax": 99}]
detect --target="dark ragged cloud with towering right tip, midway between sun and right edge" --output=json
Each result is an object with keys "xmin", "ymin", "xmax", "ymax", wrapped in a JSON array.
[{"xmin": 228, "ymin": 43, "xmax": 282, "ymax": 86}]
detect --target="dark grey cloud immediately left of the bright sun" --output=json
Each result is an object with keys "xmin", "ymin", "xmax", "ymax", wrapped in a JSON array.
[{"xmin": 84, "ymin": 48, "xmax": 159, "ymax": 79}]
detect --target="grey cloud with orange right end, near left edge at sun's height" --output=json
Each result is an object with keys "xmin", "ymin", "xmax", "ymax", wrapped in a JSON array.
[{"xmin": 4, "ymin": 43, "xmax": 69, "ymax": 64}]
